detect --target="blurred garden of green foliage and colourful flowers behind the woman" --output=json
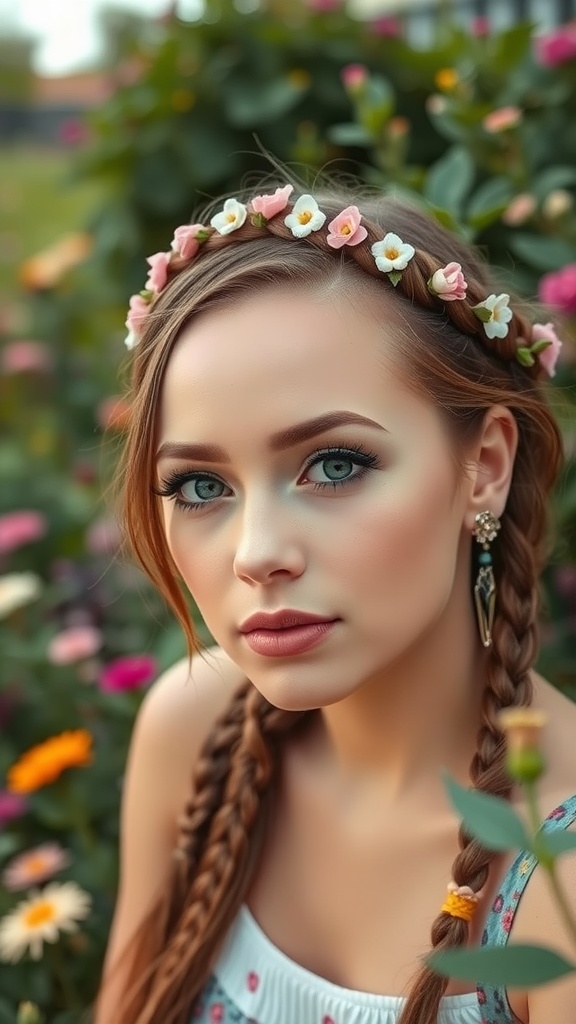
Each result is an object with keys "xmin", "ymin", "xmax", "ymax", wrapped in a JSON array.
[{"xmin": 0, "ymin": 0, "xmax": 576, "ymax": 1024}]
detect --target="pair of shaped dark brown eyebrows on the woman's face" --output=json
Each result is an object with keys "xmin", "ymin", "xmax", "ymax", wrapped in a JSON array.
[{"xmin": 156, "ymin": 411, "xmax": 386, "ymax": 462}]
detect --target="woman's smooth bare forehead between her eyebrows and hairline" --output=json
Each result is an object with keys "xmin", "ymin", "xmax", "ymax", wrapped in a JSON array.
[{"xmin": 160, "ymin": 288, "xmax": 430, "ymax": 440}]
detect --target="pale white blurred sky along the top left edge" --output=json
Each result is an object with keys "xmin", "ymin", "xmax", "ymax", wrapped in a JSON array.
[{"xmin": 0, "ymin": 0, "xmax": 385, "ymax": 75}]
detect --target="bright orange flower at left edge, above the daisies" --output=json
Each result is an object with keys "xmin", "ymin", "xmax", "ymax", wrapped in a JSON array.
[{"xmin": 6, "ymin": 729, "xmax": 92, "ymax": 793}]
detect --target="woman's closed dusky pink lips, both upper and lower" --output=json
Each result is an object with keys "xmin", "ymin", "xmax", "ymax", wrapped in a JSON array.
[{"xmin": 240, "ymin": 611, "xmax": 338, "ymax": 657}]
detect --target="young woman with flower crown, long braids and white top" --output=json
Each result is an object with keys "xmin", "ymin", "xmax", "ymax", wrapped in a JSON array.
[{"xmin": 96, "ymin": 185, "xmax": 576, "ymax": 1024}]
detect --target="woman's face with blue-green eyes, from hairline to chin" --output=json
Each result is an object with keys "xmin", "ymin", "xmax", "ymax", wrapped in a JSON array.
[{"xmin": 158, "ymin": 288, "xmax": 466, "ymax": 710}]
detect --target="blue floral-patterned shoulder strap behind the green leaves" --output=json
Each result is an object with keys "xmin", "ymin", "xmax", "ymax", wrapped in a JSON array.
[{"xmin": 477, "ymin": 795, "xmax": 576, "ymax": 1024}]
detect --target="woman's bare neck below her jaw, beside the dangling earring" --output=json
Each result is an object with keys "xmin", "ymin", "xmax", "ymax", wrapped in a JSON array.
[{"xmin": 315, "ymin": 601, "xmax": 486, "ymax": 801}]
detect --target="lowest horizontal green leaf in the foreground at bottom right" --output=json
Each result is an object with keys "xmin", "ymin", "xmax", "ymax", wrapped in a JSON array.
[{"xmin": 426, "ymin": 944, "xmax": 576, "ymax": 988}]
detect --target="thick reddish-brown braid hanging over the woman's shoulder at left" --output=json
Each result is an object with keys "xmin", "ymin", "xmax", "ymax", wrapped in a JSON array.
[{"xmin": 124, "ymin": 683, "xmax": 307, "ymax": 1024}]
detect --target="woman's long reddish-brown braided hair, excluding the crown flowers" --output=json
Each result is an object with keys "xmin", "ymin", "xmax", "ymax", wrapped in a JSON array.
[{"xmin": 105, "ymin": 182, "xmax": 562, "ymax": 1024}]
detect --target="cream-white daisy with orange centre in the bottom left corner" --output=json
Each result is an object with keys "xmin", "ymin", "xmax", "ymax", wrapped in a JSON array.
[{"xmin": 0, "ymin": 882, "xmax": 91, "ymax": 964}]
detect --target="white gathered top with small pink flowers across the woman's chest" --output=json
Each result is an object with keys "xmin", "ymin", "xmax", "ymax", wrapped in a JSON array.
[{"xmin": 207, "ymin": 906, "xmax": 482, "ymax": 1024}]
